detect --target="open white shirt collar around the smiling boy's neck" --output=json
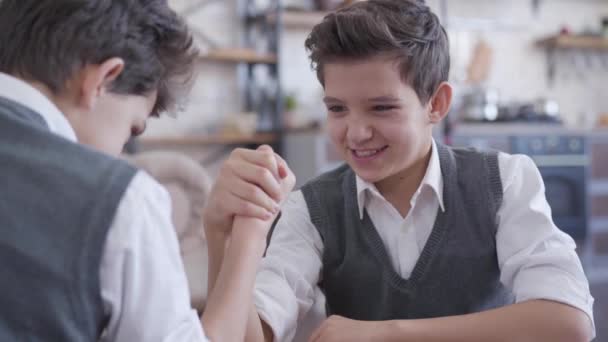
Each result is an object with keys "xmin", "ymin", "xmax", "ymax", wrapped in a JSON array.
[{"xmin": 356, "ymin": 139, "xmax": 445, "ymax": 219}]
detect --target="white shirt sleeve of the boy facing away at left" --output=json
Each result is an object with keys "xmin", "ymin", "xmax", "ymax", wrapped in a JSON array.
[{"xmin": 100, "ymin": 172, "xmax": 207, "ymax": 342}]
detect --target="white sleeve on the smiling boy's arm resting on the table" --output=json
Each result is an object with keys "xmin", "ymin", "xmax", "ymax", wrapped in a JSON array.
[{"xmin": 496, "ymin": 153, "xmax": 595, "ymax": 334}]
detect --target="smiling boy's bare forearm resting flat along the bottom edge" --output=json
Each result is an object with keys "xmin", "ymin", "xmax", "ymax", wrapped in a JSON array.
[{"xmin": 383, "ymin": 300, "xmax": 591, "ymax": 342}]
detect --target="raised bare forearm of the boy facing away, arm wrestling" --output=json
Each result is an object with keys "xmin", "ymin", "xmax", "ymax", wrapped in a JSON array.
[{"xmin": 202, "ymin": 217, "xmax": 267, "ymax": 341}]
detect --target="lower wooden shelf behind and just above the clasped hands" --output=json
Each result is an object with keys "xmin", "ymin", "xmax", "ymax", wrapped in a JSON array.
[{"xmin": 138, "ymin": 133, "xmax": 279, "ymax": 146}]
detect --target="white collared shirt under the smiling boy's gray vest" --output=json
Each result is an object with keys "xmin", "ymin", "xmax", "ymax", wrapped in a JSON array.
[{"xmin": 254, "ymin": 142, "xmax": 595, "ymax": 341}]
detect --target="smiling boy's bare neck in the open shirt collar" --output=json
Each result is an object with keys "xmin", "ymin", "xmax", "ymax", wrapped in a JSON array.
[{"xmin": 375, "ymin": 144, "xmax": 432, "ymax": 217}]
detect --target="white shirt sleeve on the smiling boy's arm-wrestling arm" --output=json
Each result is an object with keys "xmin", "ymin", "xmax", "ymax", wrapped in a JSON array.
[{"xmin": 254, "ymin": 191, "xmax": 323, "ymax": 341}]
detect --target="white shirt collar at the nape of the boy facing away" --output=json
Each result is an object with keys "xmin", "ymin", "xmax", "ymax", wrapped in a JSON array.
[{"xmin": 0, "ymin": 72, "xmax": 77, "ymax": 142}]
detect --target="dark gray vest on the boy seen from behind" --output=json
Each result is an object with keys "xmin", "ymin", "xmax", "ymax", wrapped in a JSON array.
[{"xmin": 0, "ymin": 97, "xmax": 136, "ymax": 341}]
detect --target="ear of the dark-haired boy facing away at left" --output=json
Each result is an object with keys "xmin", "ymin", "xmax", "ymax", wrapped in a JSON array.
[{"xmin": 79, "ymin": 58, "xmax": 125, "ymax": 109}]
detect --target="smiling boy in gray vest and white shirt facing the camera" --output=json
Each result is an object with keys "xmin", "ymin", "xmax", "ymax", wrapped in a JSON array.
[{"xmin": 207, "ymin": 0, "xmax": 594, "ymax": 342}]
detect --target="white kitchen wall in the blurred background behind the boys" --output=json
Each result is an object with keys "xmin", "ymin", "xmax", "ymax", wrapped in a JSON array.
[{"xmin": 147, "ymin": 0, "xmax": 608, "ymax": 139}]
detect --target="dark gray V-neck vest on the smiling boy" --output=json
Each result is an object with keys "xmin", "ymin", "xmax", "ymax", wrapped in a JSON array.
[{"xmin": 302, "ymin": 145, "xmax": 513, "ymax": 320}]
